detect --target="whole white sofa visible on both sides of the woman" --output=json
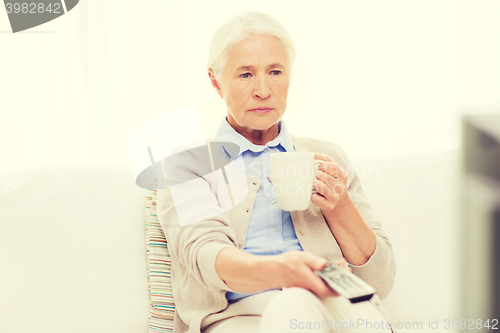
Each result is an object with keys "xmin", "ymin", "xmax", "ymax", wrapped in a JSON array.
[{"xmin": 0, "ymin": 149, "xmax": 460, "ymax": 333}]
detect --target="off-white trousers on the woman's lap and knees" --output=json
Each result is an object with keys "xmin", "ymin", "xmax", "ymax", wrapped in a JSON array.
[{"xmin": 201, "ymin": 287, "xmax": 392, "ymax": 333}]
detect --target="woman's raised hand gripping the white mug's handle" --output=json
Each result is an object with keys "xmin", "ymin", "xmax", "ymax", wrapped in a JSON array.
[{"xmin": 311, "ymin": 153, "xmax": 351, "ymax": 214}]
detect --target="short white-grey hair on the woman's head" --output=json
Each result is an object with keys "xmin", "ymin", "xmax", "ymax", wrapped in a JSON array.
[{"xmin": 207, "ymin": 12, "xmax": 295, "ymax": 81}]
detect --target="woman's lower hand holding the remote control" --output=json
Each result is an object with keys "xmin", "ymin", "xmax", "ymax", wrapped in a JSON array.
[{"xmin": 262, "ymin": 251, "xmax": 352, "ymax": 298}]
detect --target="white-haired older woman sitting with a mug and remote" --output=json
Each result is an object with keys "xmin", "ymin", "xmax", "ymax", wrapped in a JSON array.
[{"xmin": 157, "ymin": 12, "xmax": 395, "ymax": 333}]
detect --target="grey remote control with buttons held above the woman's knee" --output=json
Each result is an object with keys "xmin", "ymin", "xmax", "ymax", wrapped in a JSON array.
[{"xmin": 316, "ymin": 263, "xmax": 376, "ymax": 303}]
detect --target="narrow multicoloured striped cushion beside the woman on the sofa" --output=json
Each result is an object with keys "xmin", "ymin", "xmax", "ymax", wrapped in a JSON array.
[{"xmin": 145, "ymin": 189, "xmax": 175, "ymax": 333}]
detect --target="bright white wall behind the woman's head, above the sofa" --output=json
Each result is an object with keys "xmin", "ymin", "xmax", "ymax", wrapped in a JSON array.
[{"xmin": 0, "ymin": 0, "xmax": 500, "ymax": 173}]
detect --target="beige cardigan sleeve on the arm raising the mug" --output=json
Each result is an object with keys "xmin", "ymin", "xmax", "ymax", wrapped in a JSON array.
[{"xmin": 338, "ymin": 147, "xmax": 396, "ymax": 299}]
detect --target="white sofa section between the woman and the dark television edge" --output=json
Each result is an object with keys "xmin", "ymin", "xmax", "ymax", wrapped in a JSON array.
[{"xmin": 352, "ymin": 149, "xmax": 460, "ymax": 324}]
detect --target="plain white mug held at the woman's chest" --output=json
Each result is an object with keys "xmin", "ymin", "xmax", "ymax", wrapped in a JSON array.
[{"xmin": 270, "ymin": 152, "xmax": 323, "ymax": 211}]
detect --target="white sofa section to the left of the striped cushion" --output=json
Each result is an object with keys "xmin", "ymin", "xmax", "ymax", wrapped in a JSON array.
[{"xmin": 0, "ymin": 167, "xmax": 149, "ymax": 333}]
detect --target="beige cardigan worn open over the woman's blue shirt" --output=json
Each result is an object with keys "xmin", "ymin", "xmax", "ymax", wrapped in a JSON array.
[{"xmin": 156, "ymin": 135, "xmax": 396, "ymax": 333}]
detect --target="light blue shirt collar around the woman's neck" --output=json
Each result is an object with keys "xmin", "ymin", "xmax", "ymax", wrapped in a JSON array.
[{"xmin": 215, "ymin": 116, "xmax": 295, "ymax": 159}]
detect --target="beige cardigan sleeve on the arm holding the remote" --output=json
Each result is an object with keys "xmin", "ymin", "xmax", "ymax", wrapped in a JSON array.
[{"xmin": 156, "ymin": 167, "xmax": 241, "ymax": 291}]
